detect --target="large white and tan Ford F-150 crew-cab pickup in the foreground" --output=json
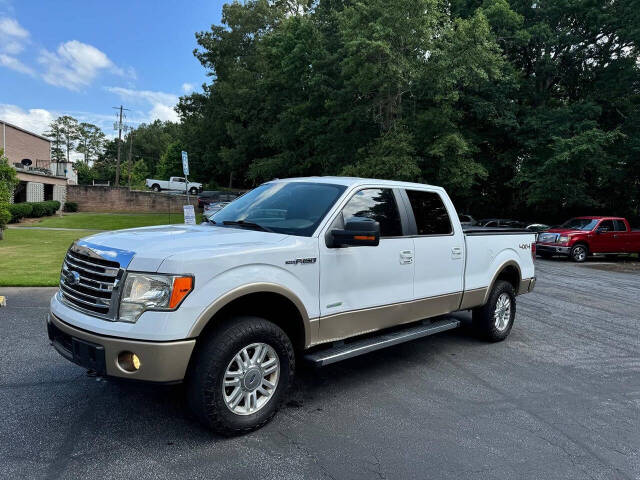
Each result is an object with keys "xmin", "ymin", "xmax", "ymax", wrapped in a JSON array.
[{"xmin": 47, "ymin": 177, "xmax": 535, "ymax": 434}]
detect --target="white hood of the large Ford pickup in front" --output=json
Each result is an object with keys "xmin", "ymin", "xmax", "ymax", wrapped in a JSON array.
[{"xmin": 82, "ymin": 225, "xmax": 287, "ymax": 272}]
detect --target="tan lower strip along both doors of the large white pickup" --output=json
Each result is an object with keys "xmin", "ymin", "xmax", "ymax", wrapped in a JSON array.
[{"xmin": 315, "ymin": 292, "xmax": 462, "ymax": 344}]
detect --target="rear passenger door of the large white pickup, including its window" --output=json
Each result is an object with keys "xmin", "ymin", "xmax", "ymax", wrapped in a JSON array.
[{"xmin": 403, "ymin": 189, "xmax": 465, "ymax": 317}]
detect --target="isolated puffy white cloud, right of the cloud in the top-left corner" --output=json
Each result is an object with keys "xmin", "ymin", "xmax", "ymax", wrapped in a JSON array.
[{"xmin": 38, "ymin": 40, "xmax": 123, "ymax": 90}]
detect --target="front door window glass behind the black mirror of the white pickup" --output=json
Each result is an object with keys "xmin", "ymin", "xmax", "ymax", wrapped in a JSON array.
[{"xmin": 342, "ymin": 188, "xmax": 402, "ymax": 237}]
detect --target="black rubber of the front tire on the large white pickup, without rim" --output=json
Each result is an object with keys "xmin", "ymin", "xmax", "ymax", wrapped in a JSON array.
[{"xmin": 187, "ymin": 317, "xmax": 295, "ymax": 435}]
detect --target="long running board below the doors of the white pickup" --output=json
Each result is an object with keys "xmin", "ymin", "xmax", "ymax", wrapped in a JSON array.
[{"xmin": 304, "ymin": 318, "xmax": 460, "ymax": 367}]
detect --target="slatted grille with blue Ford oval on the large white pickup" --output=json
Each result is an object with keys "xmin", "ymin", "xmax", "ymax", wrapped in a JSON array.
[{"xmin": 60, "ymin": 247, "xmax": 123, "ymax": 318}]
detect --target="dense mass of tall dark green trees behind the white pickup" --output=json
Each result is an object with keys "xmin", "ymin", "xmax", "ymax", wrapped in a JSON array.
[{"xmin": 178, "ymin": 0, "xmax": 640, "ymax": 222}]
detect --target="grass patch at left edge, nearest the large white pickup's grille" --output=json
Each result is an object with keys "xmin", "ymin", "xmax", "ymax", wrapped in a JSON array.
[{"xmin": 0, "ymin": 228, "xmax": 96, "ymax": 287}]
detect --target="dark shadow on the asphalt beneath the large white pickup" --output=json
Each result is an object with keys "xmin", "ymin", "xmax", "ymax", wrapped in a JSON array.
[{"xmin": 85, "ymin": 313, "xmax": 485, "ymax": 442}]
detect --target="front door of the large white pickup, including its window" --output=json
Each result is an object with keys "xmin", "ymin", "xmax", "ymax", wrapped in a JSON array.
[{"xmin": 319, "ymin": 188, "xmax": 413, "ymax": 341}]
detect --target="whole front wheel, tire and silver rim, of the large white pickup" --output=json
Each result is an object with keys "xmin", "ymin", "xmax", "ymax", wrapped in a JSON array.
[{"xmin": 187, "ymin": 317, "xmax": 295, "ymax": 435}]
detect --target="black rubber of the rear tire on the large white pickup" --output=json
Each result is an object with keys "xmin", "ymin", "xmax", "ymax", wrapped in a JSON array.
[{"xmin": 473, "ymin": 280, "xmax": 516, "ymax": 342}]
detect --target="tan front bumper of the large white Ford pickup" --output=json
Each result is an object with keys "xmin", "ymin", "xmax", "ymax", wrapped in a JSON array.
[{"xmin": 48, "ymin": 314, "xmax": 196, "ymax": 383}]
